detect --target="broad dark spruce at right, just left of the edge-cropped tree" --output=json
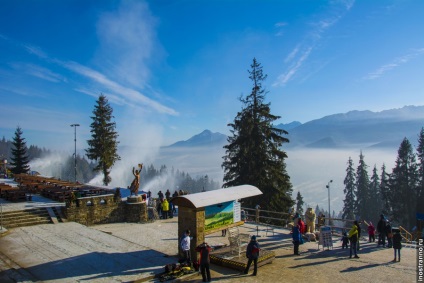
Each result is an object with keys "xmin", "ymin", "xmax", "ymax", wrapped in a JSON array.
[{"xmin": 389, "ymin": 138, "xmax": 418, "ymax": 229}]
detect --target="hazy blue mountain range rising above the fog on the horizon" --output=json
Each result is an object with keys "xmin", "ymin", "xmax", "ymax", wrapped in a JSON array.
[{"xmin": 168, "ymin": 106, "xmax": 424, "ymax": 151}]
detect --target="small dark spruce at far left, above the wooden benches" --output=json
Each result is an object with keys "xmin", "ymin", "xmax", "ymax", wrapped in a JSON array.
[{"xmin": 10, "ymin": 126, "xmax": 30, "ymax": 174}]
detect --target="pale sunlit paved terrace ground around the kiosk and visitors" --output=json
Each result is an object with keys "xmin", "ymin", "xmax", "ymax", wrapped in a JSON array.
[{"xmin": 0, "ymin": 196, "xmax": 416, "ymax": 283}]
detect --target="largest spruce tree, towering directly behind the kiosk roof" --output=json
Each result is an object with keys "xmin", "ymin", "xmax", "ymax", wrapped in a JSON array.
[{"xmin": 222, "ymin": 59, "xmax": 294, "ymax": 211}]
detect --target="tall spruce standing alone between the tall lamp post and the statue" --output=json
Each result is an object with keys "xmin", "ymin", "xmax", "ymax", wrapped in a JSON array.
[{"xmin": 85, "ymin": 94, "xmax": 120, "ymax": 186}]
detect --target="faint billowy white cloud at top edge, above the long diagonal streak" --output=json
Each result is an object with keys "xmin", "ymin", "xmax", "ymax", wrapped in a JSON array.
[{"xmin": 97, "ymin": 1, "xmax": 161, "ymax": 87}]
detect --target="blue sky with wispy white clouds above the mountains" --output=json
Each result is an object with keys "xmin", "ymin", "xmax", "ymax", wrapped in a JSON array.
[{"xmin": 0, "ymin": 0, "xmax": 424, "ymax": 151}]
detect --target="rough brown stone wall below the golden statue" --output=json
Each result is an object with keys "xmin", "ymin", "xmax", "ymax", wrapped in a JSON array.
[{"xmin": 63, "ymin": 195, "xmax": 147, "ymax": 226}]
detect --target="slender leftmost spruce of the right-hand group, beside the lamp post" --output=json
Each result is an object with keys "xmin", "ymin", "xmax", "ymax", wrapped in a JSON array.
[{"xmin": 342, "ymin": 157, "xmax": 356, "ymax": 224}]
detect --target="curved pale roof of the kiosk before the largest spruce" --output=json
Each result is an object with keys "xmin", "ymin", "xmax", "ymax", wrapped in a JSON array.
[{"xmin": 172, "ymin": 185, "xmax": 262, "ymax": 208}]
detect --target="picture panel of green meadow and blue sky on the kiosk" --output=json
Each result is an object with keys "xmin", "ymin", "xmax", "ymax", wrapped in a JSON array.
[{"xmin": 205, "ymin": 201, "xmax": 234, "ymax": 231}]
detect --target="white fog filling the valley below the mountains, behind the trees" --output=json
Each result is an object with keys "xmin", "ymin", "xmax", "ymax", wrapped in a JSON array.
[{"xmin": 30, "ymin": 147, "xmax": 397, "ymax": 213}]
